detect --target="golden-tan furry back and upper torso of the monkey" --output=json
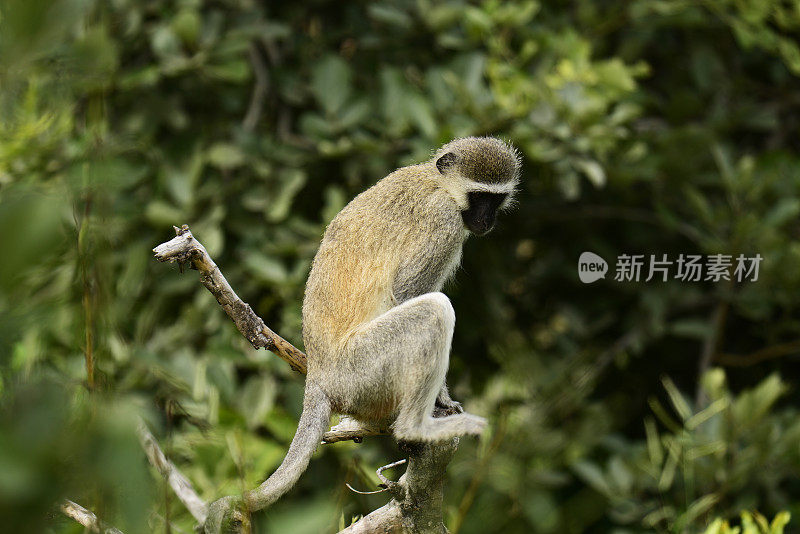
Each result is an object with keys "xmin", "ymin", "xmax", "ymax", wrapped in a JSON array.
[{"xmin": 303, "ymin": 164, "xmax": 465, "ymax": 367}]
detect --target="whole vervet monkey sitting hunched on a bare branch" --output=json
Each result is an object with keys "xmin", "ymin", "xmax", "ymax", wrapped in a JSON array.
[{"xmin": 244, "ymin": 137, "xmax": 520, "ymax": 510}]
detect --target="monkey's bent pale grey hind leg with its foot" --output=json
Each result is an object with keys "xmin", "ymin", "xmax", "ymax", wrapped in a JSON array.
[{"xmin": 348, "ymin": 293, "xmax": 486, "ymax": 441}]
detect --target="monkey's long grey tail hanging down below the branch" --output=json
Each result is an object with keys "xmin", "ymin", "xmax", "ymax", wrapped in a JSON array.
[{"xmin": 244, "ymin": 379, "xmax": 331, "ymax": 512}]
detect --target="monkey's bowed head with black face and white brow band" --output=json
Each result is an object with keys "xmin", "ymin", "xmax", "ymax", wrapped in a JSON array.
[{"xmin": 433, "ymin": 137, "xmax": 520, "ymax": 235}]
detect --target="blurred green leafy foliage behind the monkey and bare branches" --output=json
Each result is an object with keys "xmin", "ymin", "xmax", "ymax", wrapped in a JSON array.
[{"xmin": 0, "ymin": 0, "xmax": 800, "ymax": 534}]
